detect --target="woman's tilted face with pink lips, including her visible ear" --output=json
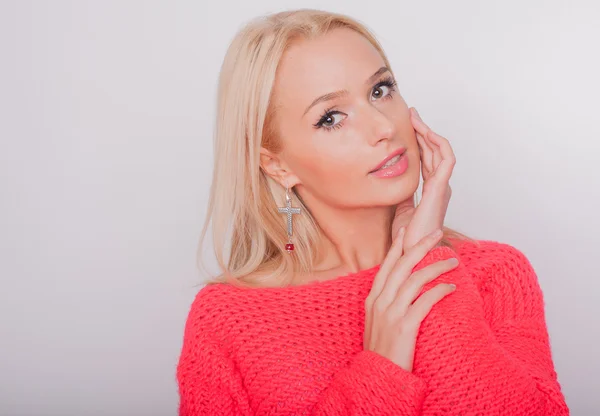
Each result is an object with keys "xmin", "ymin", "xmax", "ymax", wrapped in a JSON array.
[{"xmin": 261, "ymin": 29, "xmax": 420, "ymax": 208}]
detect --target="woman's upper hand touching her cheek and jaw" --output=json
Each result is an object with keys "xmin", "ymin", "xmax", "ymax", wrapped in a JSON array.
[{"xmin": 392, "ymin": 107, "xmax": 456, "ymax": 249}]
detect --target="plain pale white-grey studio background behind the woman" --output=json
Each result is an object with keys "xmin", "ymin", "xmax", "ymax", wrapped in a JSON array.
[{"xmin": 0, "ymin": 0, "xmax": 600, "ymax": 416}]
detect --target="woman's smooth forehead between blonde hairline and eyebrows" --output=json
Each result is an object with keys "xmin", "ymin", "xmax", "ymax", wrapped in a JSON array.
[{"xmin": 275, "ymin": 28, "xmax": 385, "ymax": 107}]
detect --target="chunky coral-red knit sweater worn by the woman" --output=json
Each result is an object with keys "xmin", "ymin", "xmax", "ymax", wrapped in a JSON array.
[{"xmin": 177, "ymin": 240, "xmax": 569, "ymax": 416}]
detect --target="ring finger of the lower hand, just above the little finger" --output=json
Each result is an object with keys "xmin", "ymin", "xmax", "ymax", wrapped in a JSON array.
[{"xmin": 391, "ymin": 258, "xmax": 458, "ymax": 317}]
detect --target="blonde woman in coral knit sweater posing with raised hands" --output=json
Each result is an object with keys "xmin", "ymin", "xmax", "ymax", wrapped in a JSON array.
[{"xmin": 177, "ymin": 10, "xmax": 569, "ymax": 416}]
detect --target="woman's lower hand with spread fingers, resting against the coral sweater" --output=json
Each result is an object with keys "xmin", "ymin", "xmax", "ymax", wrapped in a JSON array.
[{"xmin": 363, "ymin": 227, "xmax": 458, "ymax": 371}]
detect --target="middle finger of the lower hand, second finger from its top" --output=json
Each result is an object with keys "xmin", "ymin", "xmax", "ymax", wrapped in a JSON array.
[{"xmin": 378, "ymin": 230, "xmax": 443, "ymax": 305}]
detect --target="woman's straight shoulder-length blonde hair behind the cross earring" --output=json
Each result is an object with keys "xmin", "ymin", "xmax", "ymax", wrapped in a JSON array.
[{"xmin": 199, "ymin": 9, "xmax": 466, "ymax": 286}]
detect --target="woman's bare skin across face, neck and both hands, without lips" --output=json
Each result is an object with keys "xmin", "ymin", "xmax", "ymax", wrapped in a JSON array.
[{"xmin": 261, "ymin": 29, "xmax": 458, "ymax": 371}]
